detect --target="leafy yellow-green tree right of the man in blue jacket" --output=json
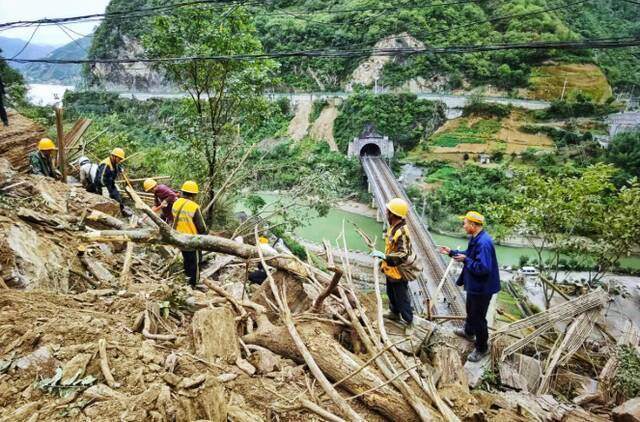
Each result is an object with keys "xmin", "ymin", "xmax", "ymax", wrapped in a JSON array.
[{"xmin": 492, "ymin": 164, "xmax": 620, "ymax": 307}]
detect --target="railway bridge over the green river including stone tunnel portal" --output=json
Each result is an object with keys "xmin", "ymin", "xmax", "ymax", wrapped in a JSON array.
[{"xmin": 349, "ymin": 127, "xmax": 465, "ymax": 315}]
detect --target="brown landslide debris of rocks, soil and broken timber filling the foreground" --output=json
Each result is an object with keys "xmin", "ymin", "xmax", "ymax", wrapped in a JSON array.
[{"xmin": 0, "ymin": 154, "xmax": 638, "ymax": 422}]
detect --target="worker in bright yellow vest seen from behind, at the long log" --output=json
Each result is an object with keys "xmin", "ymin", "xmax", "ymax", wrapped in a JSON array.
[{"xmin": 171, "ymin": 180, "xmax": 208, "ymax": 288}]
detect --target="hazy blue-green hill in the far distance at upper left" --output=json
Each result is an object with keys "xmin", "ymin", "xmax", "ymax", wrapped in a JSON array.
[{"xmin": 22, "ymin": 35, "xmax": 92, "ymax": 85}]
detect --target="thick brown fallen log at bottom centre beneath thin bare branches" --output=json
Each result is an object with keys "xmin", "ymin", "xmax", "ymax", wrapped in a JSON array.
[{"xmin": 242, "ymin": 317, "xmax": 417, "ymax": 421}]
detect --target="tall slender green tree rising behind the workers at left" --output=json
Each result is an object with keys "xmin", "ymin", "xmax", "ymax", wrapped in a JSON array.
[{"xmin": 142, "ymin": 5, "xmax": 276, "ymax": 219}]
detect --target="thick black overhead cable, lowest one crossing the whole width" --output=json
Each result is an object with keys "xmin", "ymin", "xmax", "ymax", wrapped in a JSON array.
[{"xmin": 7, "ymin": 37, "xmax": 640, "ymax": 64}]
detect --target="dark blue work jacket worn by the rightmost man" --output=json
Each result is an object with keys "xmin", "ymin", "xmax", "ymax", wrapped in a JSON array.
[{"xmin": 449, "ymin": 230, "xmax": 500, "ymax": 295}]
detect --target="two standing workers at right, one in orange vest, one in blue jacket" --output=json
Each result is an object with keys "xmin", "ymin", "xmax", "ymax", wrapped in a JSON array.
[{"xmin": 371, "ymin": 198, "xmax": 500, "ymax": 362}]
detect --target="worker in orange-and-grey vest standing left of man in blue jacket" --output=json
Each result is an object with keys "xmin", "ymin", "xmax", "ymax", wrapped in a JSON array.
[{"xmin": 371, "ymin": 198, "xmax": 417, "ymax": 335}]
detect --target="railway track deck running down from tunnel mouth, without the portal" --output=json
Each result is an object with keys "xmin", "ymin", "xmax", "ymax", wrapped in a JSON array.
[{"xmin": 362, "ymin": 156, "xmax": 465, "ymax": 315}]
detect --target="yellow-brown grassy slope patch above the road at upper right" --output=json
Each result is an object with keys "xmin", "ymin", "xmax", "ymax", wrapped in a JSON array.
[{"xmin": 529, "ymin": 64, "xmax": 612, "ymax": 103}]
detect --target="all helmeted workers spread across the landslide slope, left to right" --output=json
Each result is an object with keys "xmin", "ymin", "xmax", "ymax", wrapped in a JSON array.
[{"xmin": 29, "ymin": 138, "xmax": 500, "ymax": 356}]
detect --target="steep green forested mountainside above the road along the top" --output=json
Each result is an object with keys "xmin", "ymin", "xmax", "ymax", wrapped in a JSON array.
[{"xmin": 86, "ymin": 0, "xmax": 640, "ymax": 91}]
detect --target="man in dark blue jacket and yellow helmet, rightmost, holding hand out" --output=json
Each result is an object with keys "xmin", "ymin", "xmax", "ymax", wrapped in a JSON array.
[{"xmin": 439, "ymin": 211, "xmax": 500, "ymax": 362}]
